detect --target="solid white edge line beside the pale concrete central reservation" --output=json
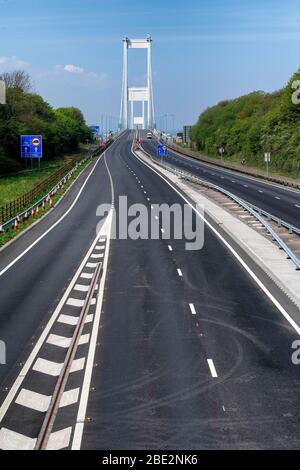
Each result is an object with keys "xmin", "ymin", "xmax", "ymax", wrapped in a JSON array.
[{"xmin": 131, "ymin": 147, "xmax": 300, "ymax": 336}]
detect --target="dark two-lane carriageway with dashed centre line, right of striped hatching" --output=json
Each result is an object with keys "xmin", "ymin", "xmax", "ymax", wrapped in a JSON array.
[{"xmin": 82, "ymin": 131, "xmax": 300, "ymax": 449}]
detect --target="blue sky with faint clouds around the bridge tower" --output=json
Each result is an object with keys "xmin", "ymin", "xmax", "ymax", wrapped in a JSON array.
[{"xmin": 0, "ymin": 0, "xmax": 300, "ymax": 130}]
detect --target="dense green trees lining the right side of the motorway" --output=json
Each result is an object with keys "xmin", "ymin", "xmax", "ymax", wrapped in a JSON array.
[{"xmin": 191, "ymin": 69, "xmax": 300, "ymax": 174}]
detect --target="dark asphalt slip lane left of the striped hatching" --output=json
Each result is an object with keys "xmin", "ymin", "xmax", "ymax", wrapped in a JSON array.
[{"xmin": 0, "ymin": 138, "xmax": 127, "ymax": 392}]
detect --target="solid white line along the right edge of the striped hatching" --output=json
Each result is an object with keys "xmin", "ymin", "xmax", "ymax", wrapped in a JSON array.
[{"xmin": 71, "ymin": 152, "xmax": 114, "ymax": 450}]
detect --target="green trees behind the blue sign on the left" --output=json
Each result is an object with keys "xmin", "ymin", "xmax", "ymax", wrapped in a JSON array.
[{"xmin": 0, "ymin": 72, "xmax": 92, "ymax": 174}]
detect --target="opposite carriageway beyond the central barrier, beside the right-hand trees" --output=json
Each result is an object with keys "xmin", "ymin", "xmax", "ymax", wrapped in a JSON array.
[{"xmin": 143, "ymin": 140, "xmax": 300, "ymax": 229}]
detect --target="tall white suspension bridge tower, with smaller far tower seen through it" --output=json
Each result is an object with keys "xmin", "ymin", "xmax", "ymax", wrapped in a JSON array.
[{"xmin": 120, "ymin": 36, "xmax": 154, "ymax": 129}]
